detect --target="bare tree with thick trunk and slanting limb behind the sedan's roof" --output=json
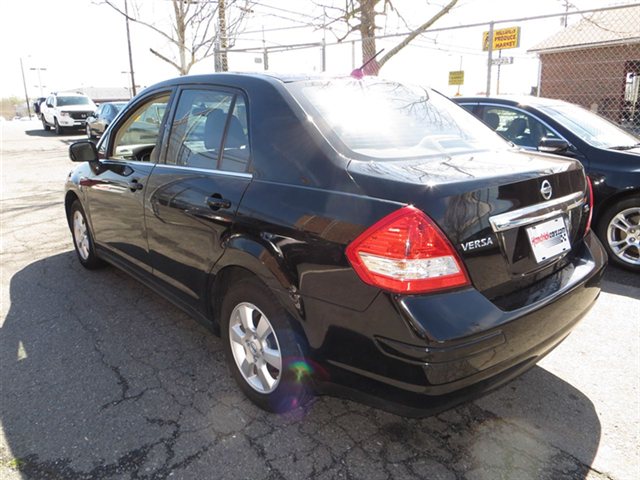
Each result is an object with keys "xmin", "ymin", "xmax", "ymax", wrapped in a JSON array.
[{"xmin": 320, "ymin": 0, "xmax": 458, "ymax": 75}]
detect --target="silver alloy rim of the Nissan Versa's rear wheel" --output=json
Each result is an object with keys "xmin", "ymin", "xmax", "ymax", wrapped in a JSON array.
[{"xmin": 229, "ymin": 302, "xmax": 282, "ymax": 393}]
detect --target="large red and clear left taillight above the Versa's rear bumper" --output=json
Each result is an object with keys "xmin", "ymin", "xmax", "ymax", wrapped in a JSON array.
[{"xmin": 347, "ymin": 206, "xmax": 469, "ymax": 294}]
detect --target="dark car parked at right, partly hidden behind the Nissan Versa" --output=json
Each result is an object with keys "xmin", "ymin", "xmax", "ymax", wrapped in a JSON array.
[{"xmin": 453, "ymin": 97, "xmax": 640, "ymax": 272}]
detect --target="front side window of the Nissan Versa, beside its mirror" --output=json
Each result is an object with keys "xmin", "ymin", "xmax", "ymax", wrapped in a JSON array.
[{"xmin": 110, "ymin": 93, "xmax": 170, "ymax": 162}]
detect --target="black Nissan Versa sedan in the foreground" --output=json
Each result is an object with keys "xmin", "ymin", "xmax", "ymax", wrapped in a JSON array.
[{"xmin": 65, "ymin": 74, "xmax": 606, "ymax": 415}]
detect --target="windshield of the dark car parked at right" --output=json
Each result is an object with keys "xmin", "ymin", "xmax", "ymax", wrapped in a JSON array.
[{"xmin": 539, "ymin": 104, "xmax": 639, "ymax": 148}]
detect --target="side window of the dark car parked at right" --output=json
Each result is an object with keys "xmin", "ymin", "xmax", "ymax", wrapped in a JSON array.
[{"xmin": 482, "ymin": 106, "xmax": 558, "ymax": 148}]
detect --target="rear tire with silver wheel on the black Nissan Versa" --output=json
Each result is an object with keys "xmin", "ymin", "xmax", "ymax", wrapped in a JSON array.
[{"xmin": 220, "ymin": 277, "xmax": 313, "ymax": 413}]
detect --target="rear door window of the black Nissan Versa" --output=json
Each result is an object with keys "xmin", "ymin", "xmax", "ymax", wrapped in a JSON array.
[{"xmin": 166, "ymin": 89, "xmax": 249, "ymax": 172}]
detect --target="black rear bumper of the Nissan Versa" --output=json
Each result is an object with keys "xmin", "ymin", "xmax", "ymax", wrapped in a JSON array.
[{"xmin": 312, "ymin": 233, "xmax": 606, "ymax": 416}]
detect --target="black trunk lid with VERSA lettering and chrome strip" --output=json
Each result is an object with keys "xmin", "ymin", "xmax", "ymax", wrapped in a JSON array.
[{"xmin": 347, "ymin": 150, "xmax": 588, "ymax": 299}]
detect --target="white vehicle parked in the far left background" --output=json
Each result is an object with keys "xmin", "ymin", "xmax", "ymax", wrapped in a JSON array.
[{"xmin": 40, "ymin": 92, "xmax": 97, "ymax": 135}]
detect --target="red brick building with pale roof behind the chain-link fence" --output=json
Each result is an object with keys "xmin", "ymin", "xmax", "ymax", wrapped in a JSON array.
[{"xmin": 529, "ymin": 6, "xmax": 640, "ymax": 124}]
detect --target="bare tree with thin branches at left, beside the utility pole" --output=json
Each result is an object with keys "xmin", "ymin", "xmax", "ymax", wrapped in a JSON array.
[{"xmin": 101, "ymin": 0, "xmax": 253, "ymax": 75}]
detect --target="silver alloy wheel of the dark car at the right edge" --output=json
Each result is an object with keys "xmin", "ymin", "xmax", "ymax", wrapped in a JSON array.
[{"xmin": 607, "ymin": 207, "xmax": 640, "ymax": 268}]
